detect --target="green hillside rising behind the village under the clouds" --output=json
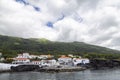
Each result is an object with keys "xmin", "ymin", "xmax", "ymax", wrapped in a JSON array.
[{"xmin": 0, "ymin": 35, "xmax": 120, "ymax": 57}]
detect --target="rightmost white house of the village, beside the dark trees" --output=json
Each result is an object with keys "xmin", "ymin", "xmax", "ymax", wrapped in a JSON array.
[{"xmin": 73, "ymin": 58, "xmax": 90, "ymax": 66}]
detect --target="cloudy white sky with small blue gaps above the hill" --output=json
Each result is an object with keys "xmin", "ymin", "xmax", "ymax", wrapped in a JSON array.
[{"xmin": 0, "ymin": 0, "xmax": 120, "ymax": 50}]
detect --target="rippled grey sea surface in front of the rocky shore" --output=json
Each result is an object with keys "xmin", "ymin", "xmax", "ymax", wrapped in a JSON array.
[{"xmin": 0, "ymin": 68, "xmax": 120, "ymax": 80}]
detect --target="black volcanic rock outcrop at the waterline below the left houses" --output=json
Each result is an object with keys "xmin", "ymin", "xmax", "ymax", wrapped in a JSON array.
[{"xmin": 11, "ymin": 65, "xmax": 39, "ymax": 72}]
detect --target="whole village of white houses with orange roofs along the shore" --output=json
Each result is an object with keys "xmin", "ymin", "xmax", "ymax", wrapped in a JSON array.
[{"xmin": 0, "ymin": 53, "xmax": 90, "ymax": 69}]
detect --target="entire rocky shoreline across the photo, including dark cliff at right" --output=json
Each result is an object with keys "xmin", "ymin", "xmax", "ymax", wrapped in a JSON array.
[{"xmin": 0, "ymin": 59, "xmax": 120, "ymax": 73}]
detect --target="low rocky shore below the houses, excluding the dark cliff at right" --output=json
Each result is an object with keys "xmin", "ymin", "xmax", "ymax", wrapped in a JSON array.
[{"xmin": 11, "ymin": 65, "xmax": 86, "ymax": 72}]
